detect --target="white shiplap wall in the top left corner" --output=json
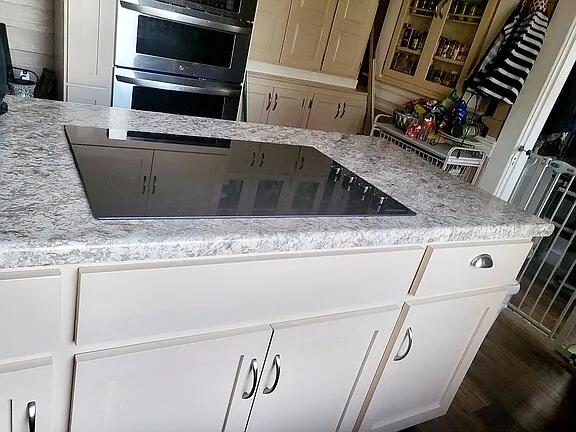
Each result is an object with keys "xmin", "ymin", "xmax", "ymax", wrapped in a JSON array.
[{"xmin": 0, "ymin": 0, "xmax": 54, "ymax": 74}]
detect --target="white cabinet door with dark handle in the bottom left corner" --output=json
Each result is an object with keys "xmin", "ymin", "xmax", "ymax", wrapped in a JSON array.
[{"xmin": 0, "ymin": 357, "xmax": 52, "ymax": 432}]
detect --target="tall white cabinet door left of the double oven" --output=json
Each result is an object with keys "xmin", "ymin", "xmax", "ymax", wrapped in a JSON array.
[{"xmin": 68, "ymin": 0, "xmax": 116, "ymax": 89}]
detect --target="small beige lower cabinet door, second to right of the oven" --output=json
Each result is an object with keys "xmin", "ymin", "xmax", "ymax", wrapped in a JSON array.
[{"xmin": 268, "ymin": 85, "xmax": 308, "ymax": 127}]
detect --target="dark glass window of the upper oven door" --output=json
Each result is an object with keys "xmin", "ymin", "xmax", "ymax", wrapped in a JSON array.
[{"xmin": 136, "ymin": 15, "xmax": 235, "ymax": 68}]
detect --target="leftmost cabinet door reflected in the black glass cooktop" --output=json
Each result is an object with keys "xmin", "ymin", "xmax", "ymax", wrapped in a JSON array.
[{"xmin": 73, "ymin": 145, "xmax": 153, "ymax": 217}]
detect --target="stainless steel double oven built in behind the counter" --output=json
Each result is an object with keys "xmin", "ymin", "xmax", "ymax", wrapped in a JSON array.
[{"xmin": 113, "ymin": 0, "xmax": 256, "ymax": 120}]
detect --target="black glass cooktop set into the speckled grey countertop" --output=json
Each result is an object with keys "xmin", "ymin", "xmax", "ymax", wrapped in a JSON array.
[{"xmin": 66, "ymin": 126, "xmax": 415, "ymax": 219}]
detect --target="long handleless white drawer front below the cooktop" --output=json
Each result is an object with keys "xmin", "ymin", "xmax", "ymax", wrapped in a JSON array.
[{"xmin": 76, "ymin": 248, "xmax": 424, "ymax": 344}]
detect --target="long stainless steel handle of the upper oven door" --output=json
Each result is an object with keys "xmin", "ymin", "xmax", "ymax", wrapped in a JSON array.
[{"xmin": 120, "ymin": 0, "xmax": 252, "ymax": 34}]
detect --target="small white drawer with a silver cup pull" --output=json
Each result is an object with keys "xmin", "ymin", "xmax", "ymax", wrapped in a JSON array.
[{"xmin": 410, "ymin": 241, "xmax": 532, "ymax": 296}]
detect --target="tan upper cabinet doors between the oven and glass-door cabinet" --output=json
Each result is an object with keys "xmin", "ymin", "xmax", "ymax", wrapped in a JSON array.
[{"xmin": 250, "ymin": 0, "xmax": 378, "ymax": 79}]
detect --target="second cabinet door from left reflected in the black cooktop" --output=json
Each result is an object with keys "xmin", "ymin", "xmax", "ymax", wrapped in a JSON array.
[{"xmin": 146, "ymin": 150, "xmax": 227, "ymax": 216}]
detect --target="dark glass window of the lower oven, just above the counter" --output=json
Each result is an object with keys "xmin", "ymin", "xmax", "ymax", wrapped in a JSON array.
[{"xmin": 132, "ymin": 87, "xmax": 226, "ymax": 118}]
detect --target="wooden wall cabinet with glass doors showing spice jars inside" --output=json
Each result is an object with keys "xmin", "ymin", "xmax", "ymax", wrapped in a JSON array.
[{"xmin": 380, "ymin": 0, "xmax": 500, "ymax": 98}]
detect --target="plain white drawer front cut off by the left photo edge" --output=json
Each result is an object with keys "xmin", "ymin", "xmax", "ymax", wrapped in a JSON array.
[{"xmin": 0, "ymin": 271, "xmax": 61, "ymax": 360}]
